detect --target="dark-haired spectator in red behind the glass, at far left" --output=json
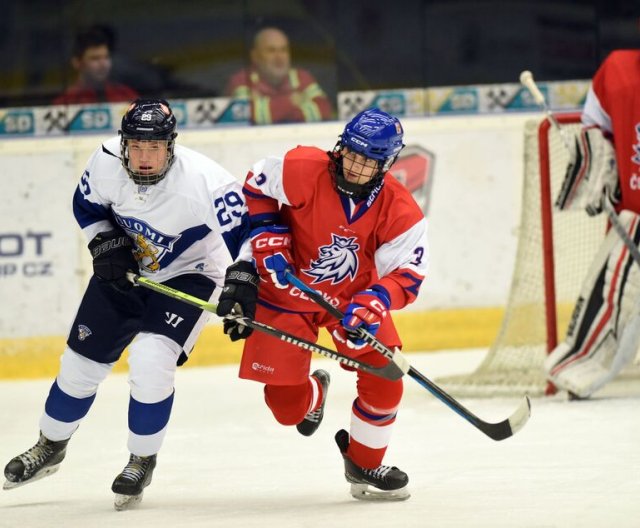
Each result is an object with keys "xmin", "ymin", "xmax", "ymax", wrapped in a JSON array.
[{"xmin": 53, "ymin": 26, "xmax": 138, "ymax": 104}]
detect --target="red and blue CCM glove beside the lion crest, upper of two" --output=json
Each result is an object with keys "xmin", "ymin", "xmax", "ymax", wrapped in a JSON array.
[{"xmin": 251, "ymin": 225, "xmax": 294, "ymax": 289}]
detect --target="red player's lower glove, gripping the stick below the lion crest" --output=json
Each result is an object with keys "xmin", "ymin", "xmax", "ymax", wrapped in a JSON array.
[{"xmin": 342, "ymin": 286, "xmax": 391, "ymax": 345}]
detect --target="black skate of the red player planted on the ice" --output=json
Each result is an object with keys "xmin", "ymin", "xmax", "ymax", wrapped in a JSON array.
[{"xmin": 336, "ymin": 429, "xmax": 411, "ymax": 501}]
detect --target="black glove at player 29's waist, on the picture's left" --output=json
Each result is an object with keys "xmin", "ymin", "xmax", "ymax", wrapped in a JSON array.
[{"xmin": 89, "ymin": 229, "xmax": 139, "ymax": 292}]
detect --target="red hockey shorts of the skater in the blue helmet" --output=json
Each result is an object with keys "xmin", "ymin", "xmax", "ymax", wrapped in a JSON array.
[{"xmin": 239, "ymin": 304, "xmax": 402, "ymax": 385}]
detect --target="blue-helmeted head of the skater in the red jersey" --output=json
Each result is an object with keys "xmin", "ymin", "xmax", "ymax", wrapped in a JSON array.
[{"xmin": 329, "ymin": 108, "xmax": 404, "ymax": 198}]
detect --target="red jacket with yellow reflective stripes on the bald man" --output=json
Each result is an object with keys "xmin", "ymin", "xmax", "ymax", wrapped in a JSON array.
[{"xmin": 226, "ymin": 68, "xmax": 333, "ymax": 125}]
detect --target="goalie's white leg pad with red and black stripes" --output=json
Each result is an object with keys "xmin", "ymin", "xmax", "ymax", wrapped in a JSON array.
[{"xmin": 544, "ymin": 210, "xmax": 640, "ymax": 398}]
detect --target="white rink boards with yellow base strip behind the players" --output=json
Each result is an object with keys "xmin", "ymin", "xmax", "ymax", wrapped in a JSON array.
[{"xmin": 0, "ymin": 113, "xmax": 537, "ymax": 378}]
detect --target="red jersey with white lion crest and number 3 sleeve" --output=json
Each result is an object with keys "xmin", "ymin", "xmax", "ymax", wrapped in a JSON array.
[{"xmin": 243, "ymin": 147, "xmax": 429, "ymax": 312}]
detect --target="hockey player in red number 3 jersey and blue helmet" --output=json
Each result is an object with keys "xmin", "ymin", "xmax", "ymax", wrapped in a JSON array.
[{"xmin": 218, "ymin": 108, "xmax": 428, "ymax": 500}]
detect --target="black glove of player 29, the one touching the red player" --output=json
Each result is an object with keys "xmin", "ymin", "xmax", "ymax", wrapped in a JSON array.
[{"xmin": 216, "ymin": 260, "xmax": 260, "ymax": 341}]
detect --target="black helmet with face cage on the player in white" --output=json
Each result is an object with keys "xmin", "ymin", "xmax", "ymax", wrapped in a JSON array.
[{"xmin": 119, "ymin": 99, "xmax": 178, "ymax": 185}]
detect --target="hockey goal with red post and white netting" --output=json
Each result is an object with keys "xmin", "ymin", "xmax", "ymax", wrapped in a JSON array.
[{"xmin": 438, "ymin": 114, "xmax": 638, "ymax": 396}]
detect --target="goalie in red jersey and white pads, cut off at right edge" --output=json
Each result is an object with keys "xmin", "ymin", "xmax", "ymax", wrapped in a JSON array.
[{"xmin": 544, "ymin": 50, "xmax": 640, "ymax": 398}]
